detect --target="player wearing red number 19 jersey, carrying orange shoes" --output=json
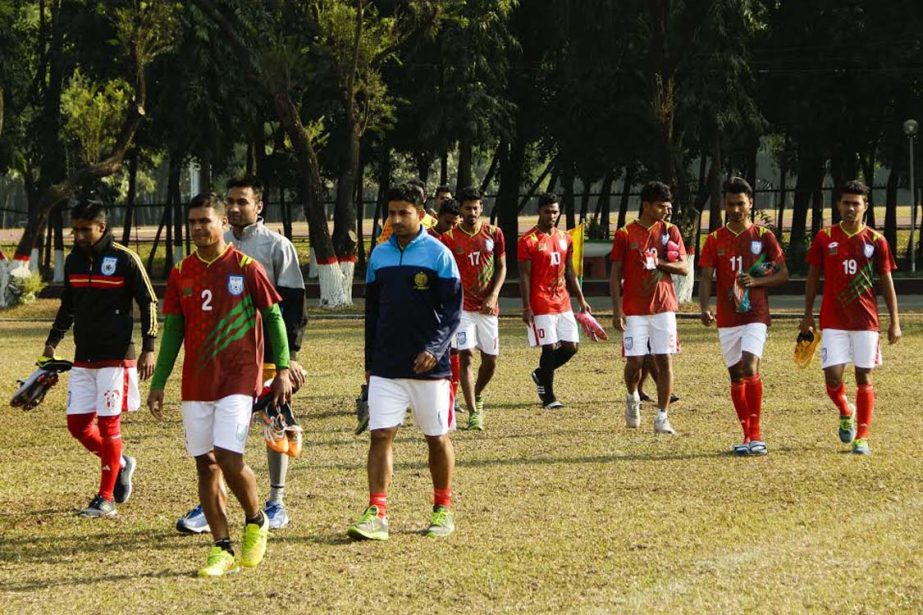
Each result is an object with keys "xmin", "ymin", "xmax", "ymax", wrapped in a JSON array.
[{"xmin": 801, "ymin": 181, "xmax": 901, "ymax": 455}]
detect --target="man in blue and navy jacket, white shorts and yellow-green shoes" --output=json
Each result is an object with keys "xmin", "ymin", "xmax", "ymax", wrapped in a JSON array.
[{"xmin": 348, "ymin": 184, "xmax": 462, "ymax": 540}]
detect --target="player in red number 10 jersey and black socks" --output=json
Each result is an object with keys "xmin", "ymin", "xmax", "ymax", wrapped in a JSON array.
[{"xmin": 516, "ymin": 193, "xmax": 591, "ymax": 410}]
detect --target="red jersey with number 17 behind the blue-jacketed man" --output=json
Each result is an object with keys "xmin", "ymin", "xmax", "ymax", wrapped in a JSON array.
[{"xmin": 441, "ymin": 222, "xmax": 506, "ymax": 314}]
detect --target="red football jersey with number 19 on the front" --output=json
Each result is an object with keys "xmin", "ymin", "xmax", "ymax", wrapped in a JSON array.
[{"xmin": 808, "ymin": 224, "xmax": 897, "ymax": 331}]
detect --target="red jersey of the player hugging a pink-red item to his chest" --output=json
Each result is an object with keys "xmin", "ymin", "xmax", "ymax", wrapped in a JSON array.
[{"xmin": 609, "ymin": 220, "xmax": 686, "ymax": 316}]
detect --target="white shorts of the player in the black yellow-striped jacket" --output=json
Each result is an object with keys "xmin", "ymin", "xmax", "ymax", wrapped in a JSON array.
[{"xmin": 67, "ymin": 367, "xmax": 141, "ymax": 416}]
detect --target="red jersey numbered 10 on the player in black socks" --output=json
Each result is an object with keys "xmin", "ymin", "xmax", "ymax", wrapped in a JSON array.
[{"xmin": 517, "ymin": 226, "xmax": 572, "ymax": 316}]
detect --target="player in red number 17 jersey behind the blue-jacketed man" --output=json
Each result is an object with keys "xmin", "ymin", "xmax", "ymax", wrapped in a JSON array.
[{"xmin": 442, "ymin": 188, "xmax": 506, "ymax": 431}]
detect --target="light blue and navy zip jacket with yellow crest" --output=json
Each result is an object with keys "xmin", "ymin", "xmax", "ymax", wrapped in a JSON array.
[{"xmin": 365, "ymin": 227, "xmax": 462, "ymax": 379}]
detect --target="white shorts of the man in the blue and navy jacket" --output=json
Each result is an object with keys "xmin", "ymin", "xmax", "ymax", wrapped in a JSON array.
[{"xmin": 369, "ymin": 376, "xmax": 455, "ymax": 436}]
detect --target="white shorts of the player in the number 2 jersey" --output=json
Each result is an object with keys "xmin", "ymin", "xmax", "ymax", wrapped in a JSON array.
[{"xmin": 183, "ymin": 395, "xmax": 253, "ymax": 457}]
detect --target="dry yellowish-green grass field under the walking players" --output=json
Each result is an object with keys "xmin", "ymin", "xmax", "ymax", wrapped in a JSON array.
[{"xmin": 0, "ymin": 312, "xmax": 923, "ymax": 613}]
